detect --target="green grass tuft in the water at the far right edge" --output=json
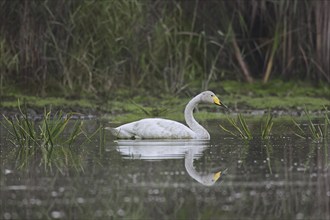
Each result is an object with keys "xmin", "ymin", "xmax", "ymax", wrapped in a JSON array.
[{"xmin": 292, "ymin": 106, "xmax": 330, "ymax": 142}]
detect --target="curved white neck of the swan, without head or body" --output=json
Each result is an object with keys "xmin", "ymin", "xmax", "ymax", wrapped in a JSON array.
[{"xmin": 184, "ymin": 96, "xmax": 210, "ymax": 139}]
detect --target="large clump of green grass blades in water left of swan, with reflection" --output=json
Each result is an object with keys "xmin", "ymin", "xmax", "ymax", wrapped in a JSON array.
[{"xmin": 1, "ymin": 103, "xmax": 99, "ymax": 172}]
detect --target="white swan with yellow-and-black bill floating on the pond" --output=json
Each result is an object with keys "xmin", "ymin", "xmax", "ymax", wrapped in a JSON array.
[{"xmin": 106, "ymin": 91, "xmax": 227, "ymax": 139}]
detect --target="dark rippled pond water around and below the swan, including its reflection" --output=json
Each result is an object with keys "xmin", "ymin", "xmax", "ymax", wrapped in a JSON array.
[{"xmin": 0, "ymin": 121, "xmax": 330, "ymax": 219}]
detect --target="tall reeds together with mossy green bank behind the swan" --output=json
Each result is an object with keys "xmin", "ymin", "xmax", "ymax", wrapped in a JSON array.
[{"xmin": 0, "ymin": 0, "xmax": 330, "ymax": 122}]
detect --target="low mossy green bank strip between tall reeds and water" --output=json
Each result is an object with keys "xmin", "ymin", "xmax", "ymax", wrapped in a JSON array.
[{"xmin": 0, "ymin": 80, "xmax": 330, "ymax": 123}]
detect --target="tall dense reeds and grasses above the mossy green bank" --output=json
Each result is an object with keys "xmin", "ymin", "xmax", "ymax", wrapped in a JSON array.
[{"xmin": 0, "ymin": 0, "xmax": 330, "ymax": 96}]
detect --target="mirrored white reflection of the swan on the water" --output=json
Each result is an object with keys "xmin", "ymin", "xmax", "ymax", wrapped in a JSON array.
[{"xmin": 115, "ymin": 140, "xmax": 224, "ymax": 186}]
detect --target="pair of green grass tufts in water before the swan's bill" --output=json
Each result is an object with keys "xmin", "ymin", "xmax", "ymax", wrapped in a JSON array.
[{"xmin": 219, "ymin": 113, "xmax": 273, "ymax": 140}]
